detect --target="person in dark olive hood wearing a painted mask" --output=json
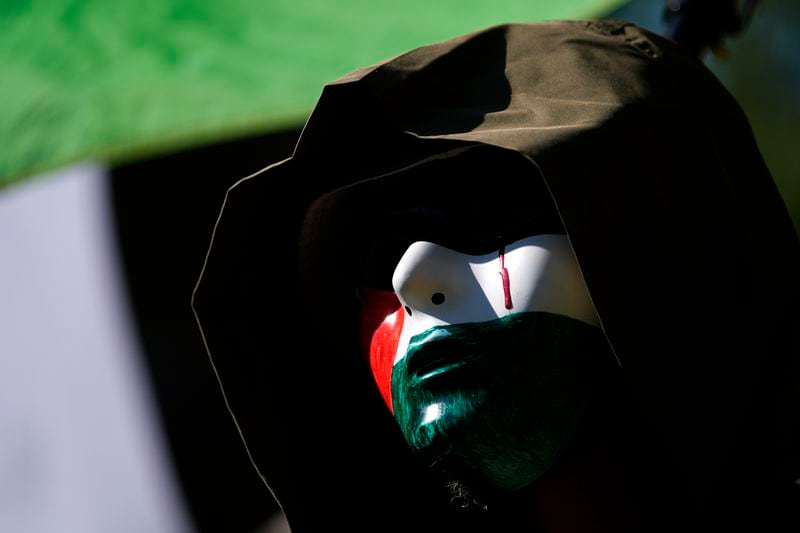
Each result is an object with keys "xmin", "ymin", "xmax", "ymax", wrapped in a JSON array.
[{"xmin": 194, "ymin": 20, "xmax": 800, "ymax": 533}]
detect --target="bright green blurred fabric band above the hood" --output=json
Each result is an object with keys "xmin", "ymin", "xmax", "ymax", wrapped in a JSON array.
[{"xmin": 0, "ymin": 0, "xmax": 621, "ymax": 187}]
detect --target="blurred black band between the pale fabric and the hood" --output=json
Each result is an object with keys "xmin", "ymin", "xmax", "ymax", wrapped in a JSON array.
[{"xmin": 112, "ymin": 129, "xmax": 300, "ymax": 533}]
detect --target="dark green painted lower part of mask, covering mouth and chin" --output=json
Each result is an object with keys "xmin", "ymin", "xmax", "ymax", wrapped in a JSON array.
[{"xmin": 392, "ymin": 312, "xmax": 610, "ymax": 491}]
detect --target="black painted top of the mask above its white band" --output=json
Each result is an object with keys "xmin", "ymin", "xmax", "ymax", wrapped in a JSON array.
[{"xmin": 360, "ymin": 150, "xmax": 566, "ymax": 290}]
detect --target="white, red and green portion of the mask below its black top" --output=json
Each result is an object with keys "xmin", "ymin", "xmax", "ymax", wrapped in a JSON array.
[{"xmin": 362, "ymin": 234, "xmax": 608, "ymax": 490}]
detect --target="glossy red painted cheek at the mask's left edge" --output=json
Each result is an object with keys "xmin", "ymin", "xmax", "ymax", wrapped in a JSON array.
[{"xmin": 359, "ymin": 289, "xmax": 405, "ymax": 412}]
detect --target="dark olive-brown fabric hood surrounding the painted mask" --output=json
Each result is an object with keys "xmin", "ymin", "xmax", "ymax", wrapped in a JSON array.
[{"xmin": 194, "ymin": 21, "xmax": 800, "ymax": 533}]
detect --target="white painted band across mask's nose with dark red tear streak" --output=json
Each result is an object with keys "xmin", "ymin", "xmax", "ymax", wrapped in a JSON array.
[{"xmin": 392, "ymin": 234, "xmax": 600, "ymax": 364}]
